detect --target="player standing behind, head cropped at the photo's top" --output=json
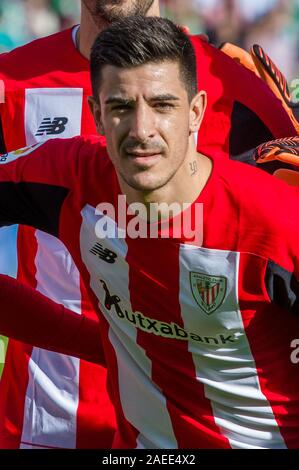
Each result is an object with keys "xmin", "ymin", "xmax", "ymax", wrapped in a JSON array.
[{"xmin": 0, "ymin": 0, "xmax": 296, "ymax": 448}]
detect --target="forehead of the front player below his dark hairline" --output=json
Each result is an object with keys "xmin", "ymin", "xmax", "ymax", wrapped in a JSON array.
[{"xmin": 99, "ymin": 62, "xmax": 186, "ymax": 97}]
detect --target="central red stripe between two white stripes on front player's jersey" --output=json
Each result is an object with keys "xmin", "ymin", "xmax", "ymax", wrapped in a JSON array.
[{"xmin": 127, "ymin": 239, "xmax": 229, "ymax": 448}]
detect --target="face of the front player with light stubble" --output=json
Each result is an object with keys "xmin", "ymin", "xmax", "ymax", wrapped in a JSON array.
[{"xmin": 93, "ymin": 62, "xmax": 203, "ymax": 191}]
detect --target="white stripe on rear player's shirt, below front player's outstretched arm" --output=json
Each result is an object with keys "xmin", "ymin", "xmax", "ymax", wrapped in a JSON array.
[{"xmin": 21, "ymin": 231, "xmax": 81, "ymax": 448}]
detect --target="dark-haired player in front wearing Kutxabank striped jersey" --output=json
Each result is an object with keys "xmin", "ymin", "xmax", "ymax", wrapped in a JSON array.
[{"xmin": 0, "ymin": 17, "xmax": 299, "ymax": 448}]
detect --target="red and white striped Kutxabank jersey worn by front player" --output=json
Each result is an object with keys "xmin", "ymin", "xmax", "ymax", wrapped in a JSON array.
[{"xmin": 0, "ymin": 137, "xmax": 299, "ymax": 448}]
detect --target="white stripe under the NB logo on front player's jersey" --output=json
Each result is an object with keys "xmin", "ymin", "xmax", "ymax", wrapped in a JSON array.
[{"xmin": 80, "ymin": 206, "xmax": 177, "ymax": 448}]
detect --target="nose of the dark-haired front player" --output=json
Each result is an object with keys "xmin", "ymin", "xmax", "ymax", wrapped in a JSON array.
[{"xmin": 129, "ymin": 102, "xmax": 155, "ymax": 142}]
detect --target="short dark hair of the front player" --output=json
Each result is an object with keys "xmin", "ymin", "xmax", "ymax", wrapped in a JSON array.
[{"xmin": 90, "ymin": 15, "xmax": 198, "ymax": 101}]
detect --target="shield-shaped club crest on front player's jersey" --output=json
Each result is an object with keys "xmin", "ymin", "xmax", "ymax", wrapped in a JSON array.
[{"xmin": 190, "ymin": 272, "xmax": 227, "ymax": 315}]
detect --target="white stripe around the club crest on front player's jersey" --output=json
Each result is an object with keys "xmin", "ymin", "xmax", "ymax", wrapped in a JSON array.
[{"xmin": 180, "ymin": 245, "xmax": 286, "ymax": 449}]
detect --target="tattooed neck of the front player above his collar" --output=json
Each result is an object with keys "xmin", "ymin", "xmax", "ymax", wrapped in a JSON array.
[{"xmin": 119, "ymin": 146, "xmax": 212, "ymax": 220}]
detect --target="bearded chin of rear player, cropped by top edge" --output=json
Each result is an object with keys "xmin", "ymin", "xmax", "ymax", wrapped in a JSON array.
[{"xmin": 82, "ymin": 0, "xmax": 155, "ymax": 23}]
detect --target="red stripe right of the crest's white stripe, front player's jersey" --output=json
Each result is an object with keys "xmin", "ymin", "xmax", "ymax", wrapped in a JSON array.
[{"xmin": 239, "ymin": 254, "xmax": 299, "ymax": 449}]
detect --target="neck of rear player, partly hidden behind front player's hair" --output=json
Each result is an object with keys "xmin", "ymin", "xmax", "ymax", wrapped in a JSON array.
[{"xmin": 77, "ymin": 0, "xmax": 160, "ymax": 59}]
